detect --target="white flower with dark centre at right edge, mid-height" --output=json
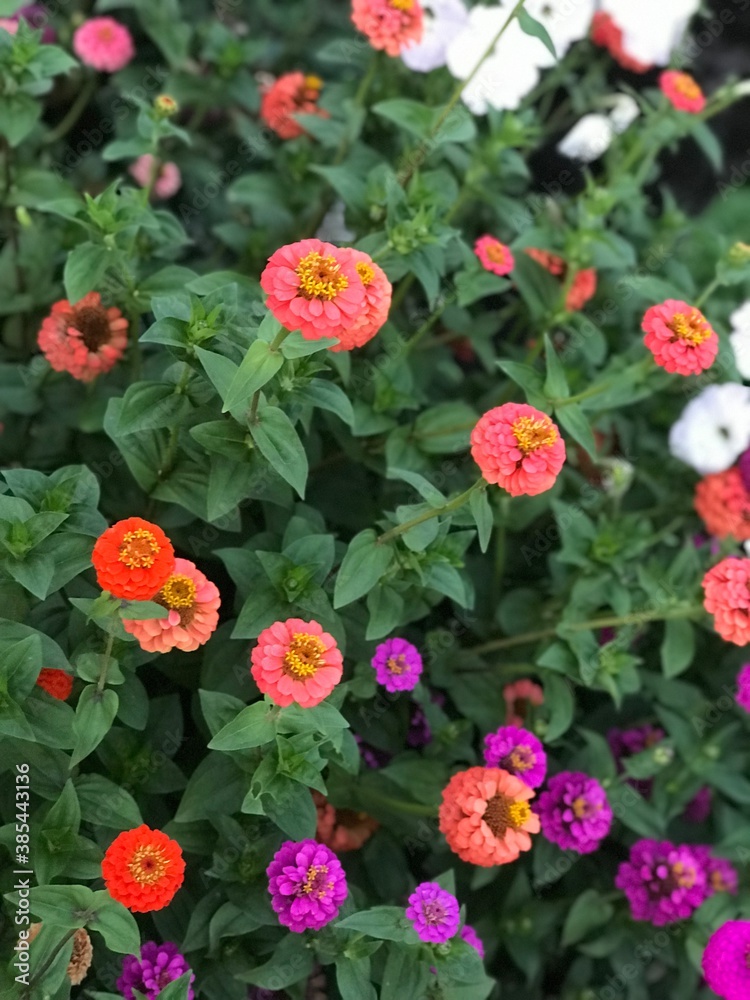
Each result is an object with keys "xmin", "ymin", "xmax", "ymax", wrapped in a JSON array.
[{"xmin": 669, "ymin": 382, "xmax": 750, "ymax": 476}]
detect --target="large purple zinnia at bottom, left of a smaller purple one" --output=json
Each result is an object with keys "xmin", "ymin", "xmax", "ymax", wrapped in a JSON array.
[{"xmin": 266, "ymin": 840, "xmax": 348, "ymax": 934}]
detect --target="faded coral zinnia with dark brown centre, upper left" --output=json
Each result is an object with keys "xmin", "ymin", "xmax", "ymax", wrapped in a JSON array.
[{"xmin": 37, "ymin": 292, "xmax": 128, "ymax": 382}]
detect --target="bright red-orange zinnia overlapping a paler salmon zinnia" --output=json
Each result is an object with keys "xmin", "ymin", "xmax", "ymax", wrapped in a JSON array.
[{"xmin": 91, "ymin": 517, "xmax": 174, "ymax": 601}]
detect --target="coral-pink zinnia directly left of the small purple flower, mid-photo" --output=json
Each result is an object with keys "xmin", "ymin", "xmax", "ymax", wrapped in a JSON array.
[{"xmin": 250, "ymin": 618, "xmax": 343, "ymax": 708}]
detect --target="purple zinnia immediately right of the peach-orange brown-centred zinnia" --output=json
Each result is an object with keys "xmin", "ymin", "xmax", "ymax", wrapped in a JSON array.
[{"xmin": 537, "ymin": 771, "xmax": 612, "ymax": 854}]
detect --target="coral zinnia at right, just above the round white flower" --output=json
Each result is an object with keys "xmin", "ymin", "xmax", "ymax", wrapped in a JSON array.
[{"xmin": 641, "ymin": 299, "xmax": 719, "ymax": 375}]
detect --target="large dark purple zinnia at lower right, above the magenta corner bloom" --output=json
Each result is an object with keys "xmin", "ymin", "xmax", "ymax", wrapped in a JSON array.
[{"xmin": 615, "ymin": 840, "xmax": 708, "ymax": 927}]
